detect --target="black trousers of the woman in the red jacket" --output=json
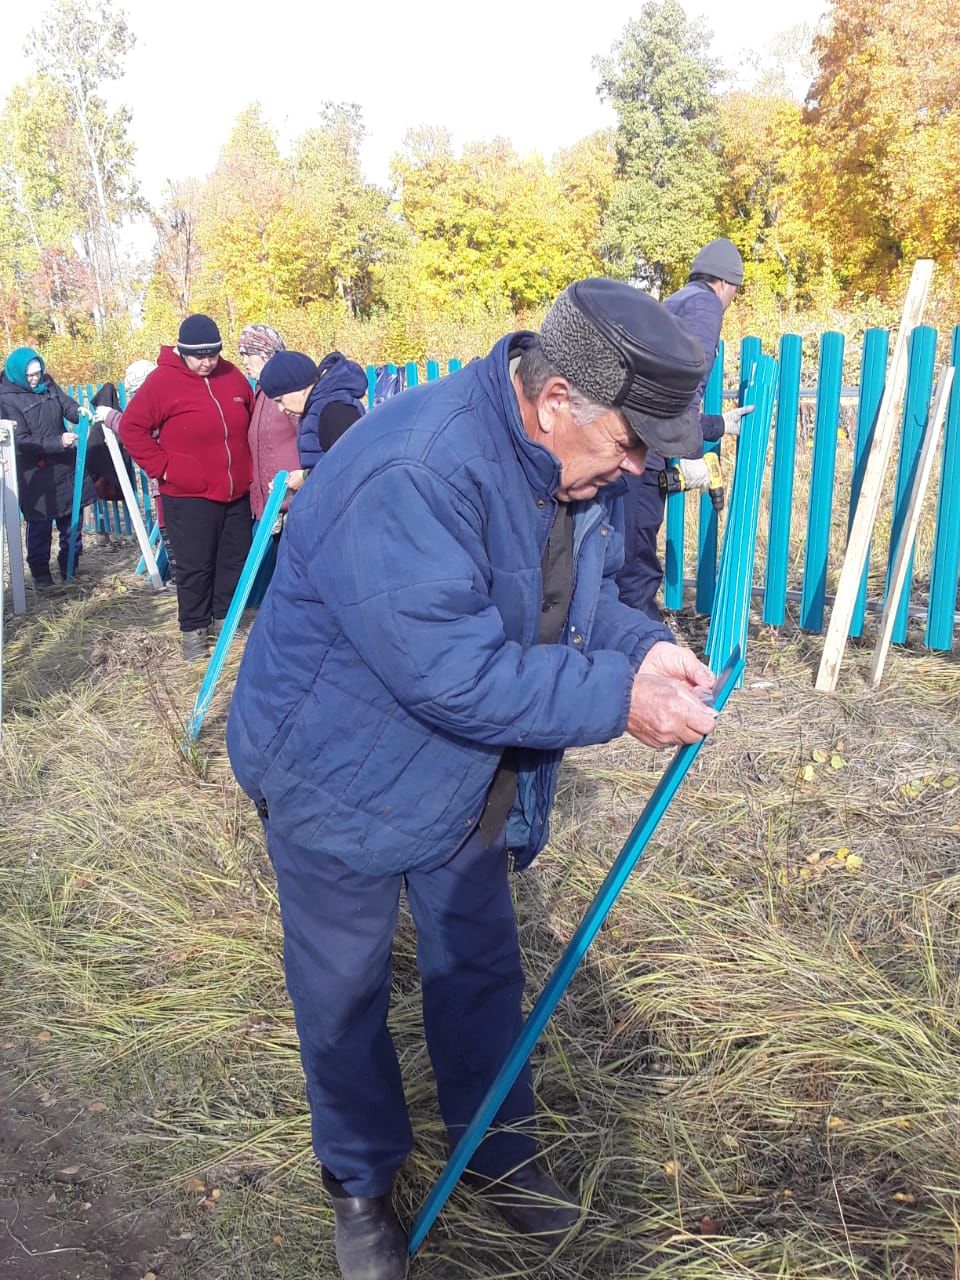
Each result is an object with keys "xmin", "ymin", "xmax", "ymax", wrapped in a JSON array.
[{"xmin": 163, "ymin": 494, "xmax": 252, "ymax": 631}]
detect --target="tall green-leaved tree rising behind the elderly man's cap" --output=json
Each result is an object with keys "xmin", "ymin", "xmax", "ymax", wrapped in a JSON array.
[{"xmin": 595, "ymin": 0, "xmax": 721, "ymax": 291}]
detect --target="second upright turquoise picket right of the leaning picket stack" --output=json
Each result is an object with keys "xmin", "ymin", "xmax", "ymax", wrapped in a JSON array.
[{"xmin": 800, "ymin": 333, "xmax": 844, "ymax": 631}]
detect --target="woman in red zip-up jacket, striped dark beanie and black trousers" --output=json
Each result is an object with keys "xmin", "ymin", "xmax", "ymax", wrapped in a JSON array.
[{"xmin": 120, "ymin": 315, "xmax": 253, "ymax": 662}]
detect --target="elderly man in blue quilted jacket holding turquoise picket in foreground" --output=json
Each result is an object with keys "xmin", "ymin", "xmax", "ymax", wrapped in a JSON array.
[{"xmin": 228, "ymin": 279, "xmax": 714, "ymax": 1280}]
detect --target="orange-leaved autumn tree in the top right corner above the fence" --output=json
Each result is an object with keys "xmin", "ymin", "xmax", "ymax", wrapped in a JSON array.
[{"xmin": 806, "ymin": 0, "xmax": 960, "ymax": 292}]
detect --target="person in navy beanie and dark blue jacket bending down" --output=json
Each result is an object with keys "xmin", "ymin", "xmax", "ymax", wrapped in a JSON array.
[{"xmin": 260, "ymin": 351, "xmax": 366, "ymax": 472}]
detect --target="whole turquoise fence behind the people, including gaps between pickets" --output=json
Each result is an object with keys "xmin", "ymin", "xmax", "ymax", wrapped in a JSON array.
[{"xmin": 67, "ymin": 326, "xmax": 960, "ymax": 652}]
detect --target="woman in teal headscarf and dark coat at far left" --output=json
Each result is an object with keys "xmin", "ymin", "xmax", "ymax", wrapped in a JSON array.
[{"xmin": 0, "ymin": 347, "xmax": 95, "ymax": 591}]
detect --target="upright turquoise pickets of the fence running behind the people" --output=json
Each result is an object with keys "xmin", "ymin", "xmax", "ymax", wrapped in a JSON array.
[{"xmin": 67, "ymin": 325, "xmax": 960, "ymax": 652}]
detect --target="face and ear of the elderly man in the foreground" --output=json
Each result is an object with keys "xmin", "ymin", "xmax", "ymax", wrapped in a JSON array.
[{"xmin": 538, "ymin": 379, "xmax": 646, "ymax": 502}]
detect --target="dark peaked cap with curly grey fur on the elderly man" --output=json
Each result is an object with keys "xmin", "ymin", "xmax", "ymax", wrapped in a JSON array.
[{"xmin": 540, "ymin": 279, "xmax": 707, "ymax": 458}]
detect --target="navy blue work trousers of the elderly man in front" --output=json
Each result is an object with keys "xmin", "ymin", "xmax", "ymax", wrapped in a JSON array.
[{"xmin": 265, "ymin": 820, "xmax": 535, "ymax": 1196}]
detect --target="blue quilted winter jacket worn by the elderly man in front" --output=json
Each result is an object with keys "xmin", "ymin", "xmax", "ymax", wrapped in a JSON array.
[{"xmin": 227, "ymin": 334, "xmax": 672, "ymax": 874}]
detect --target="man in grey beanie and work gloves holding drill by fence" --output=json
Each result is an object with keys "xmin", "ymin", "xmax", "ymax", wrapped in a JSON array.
[{"xmin": 617, "ymin": 238, "xmax": 753, "ymax": 620}]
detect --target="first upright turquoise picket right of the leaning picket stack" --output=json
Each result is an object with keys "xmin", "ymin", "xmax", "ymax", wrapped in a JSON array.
[{"xmin": 768, "ymin": 333, "xmax": 804, "ymax": 627}]
